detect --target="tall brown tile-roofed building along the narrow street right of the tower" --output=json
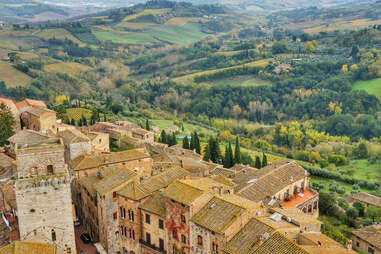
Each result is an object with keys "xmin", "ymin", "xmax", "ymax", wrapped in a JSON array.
[{"xmin": 76, "ymin": 165, "xmax": 139, "ymax": 253}]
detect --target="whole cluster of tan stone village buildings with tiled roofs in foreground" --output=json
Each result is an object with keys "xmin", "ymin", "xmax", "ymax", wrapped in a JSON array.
[{"xmin": 0, "ymin": 98, "xmax": 374, "ymax": 254}]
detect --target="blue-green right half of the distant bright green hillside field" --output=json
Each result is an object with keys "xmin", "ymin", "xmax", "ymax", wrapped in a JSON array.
[{"xmin": 145, "ymin": 23, "xmax": 206, "ymax": 45}]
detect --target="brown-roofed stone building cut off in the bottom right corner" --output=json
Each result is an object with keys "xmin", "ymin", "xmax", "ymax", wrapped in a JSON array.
[{"xmin": 352, "ymin": 225, "xmax": 381, "ymax": 254}]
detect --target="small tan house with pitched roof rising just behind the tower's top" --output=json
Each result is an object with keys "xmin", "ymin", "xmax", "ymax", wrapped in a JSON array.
[{"xmin": 21, "ymin": 107, "xmax": 57, "ymax": 133}]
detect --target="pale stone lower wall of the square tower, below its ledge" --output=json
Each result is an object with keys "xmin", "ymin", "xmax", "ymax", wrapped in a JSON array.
[{"xmin": 15, "ymin": 174, "xmax": 76, "ymax": 254}]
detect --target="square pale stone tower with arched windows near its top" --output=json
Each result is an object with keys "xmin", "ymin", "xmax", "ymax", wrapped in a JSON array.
[{"xmin": 10, "ymin": 131, "xmax": 76, "ymax": 254}]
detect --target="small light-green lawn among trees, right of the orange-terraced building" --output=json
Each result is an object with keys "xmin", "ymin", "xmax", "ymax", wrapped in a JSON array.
[{"xmin": 338, "ymin": 159, "xmax": 381, "ymax": 181}]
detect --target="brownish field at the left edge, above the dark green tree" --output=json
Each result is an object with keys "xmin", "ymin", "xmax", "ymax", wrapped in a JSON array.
[{"xmin": 0, "ymin": 61, "xmax": 32, "ymax": 87}]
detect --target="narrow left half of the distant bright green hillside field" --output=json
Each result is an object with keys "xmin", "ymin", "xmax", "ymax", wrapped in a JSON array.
[{"xmin": 93, "ymin": 30, "xmax": 156, "ymax": 45}]
